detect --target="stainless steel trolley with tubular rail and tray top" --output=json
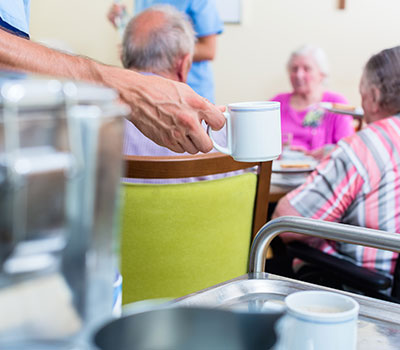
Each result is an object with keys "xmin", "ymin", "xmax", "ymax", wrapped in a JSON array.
[{"xmin": 173, "ymin": 217, "xmax": 400, "ymax": 350}]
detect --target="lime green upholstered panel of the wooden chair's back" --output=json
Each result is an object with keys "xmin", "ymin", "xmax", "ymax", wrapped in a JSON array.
[{"xmin": 121, "ymin": 173, "xmax": 257, "ymax": 304}]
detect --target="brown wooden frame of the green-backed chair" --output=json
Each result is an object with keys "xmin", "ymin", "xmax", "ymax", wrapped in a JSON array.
[{"xmin": 124, "ymin": 152, "xmax": 272, "ymax": 238}]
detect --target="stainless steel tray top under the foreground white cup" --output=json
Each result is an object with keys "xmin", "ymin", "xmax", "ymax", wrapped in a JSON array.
[{"xmin": 175, "ymin": 273, "xmax": 400, "ymax": 350}]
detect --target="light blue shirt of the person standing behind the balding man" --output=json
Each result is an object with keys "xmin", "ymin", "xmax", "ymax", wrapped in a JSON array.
[{"xmin": 135, "ymin": 0, "xmax": 223, "ymax": 102}]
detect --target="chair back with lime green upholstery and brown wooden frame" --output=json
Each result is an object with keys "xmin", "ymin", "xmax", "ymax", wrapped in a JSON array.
[{"xmin": 120, "ymin": 152, "xmax": 271, "ymax": 304}]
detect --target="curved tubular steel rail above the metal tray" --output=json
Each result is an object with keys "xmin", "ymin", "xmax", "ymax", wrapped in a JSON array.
[{"xmin": 249, "ymin": 216, "xmax": 400, "ymax": 272}]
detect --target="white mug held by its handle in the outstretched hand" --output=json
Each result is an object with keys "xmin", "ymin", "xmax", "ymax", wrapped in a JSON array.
[{"xmin": 207, "ymin": 101, "xmax": 282, "ymax": 162}]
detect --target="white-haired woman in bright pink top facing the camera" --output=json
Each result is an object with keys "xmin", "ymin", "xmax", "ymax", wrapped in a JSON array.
[{"xmin": 272, "ymin": 45, "xmax": 354, "ymax": 157}]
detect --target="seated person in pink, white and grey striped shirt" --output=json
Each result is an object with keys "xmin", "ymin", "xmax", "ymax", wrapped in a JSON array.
[{"xmin": 273, "ymin": 46, "xmax": 400, "ymax": 284}]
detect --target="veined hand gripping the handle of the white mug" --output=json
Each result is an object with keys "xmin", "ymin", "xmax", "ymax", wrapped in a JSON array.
[{"xmin": 104, "ymin": 67, "xmax": 225, "ymax": 154}]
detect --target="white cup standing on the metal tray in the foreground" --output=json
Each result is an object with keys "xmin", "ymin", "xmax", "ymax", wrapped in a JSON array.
[{"xmin": 278, "ymin": 291, "xmax": 359, "ymax": 350}]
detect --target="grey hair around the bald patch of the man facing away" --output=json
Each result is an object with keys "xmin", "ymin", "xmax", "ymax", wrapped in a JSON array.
[{"xmin": 122, "ymin": 5, "xmax": 196, "ymax": 72}]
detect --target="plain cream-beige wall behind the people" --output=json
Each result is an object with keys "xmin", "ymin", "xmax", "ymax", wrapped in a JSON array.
[{"xmin": 31, "ymin": 0, "xmax": 400, "ymax": 104}]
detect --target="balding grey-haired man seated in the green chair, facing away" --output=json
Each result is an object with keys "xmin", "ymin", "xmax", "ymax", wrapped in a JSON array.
[{"xmin": 121, "ymin": 5, "xmax": 225, "ymax": 164}]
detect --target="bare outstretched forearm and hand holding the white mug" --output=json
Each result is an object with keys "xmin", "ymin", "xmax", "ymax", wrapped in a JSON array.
[{"xmin": 0, "ymin": 30, "xmax": 225, "ymax": 153}]
